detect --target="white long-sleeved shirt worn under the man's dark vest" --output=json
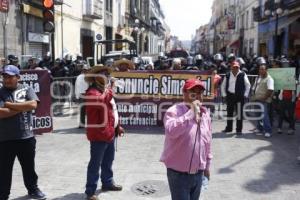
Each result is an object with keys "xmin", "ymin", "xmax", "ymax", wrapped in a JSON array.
[{"xmin": 221, "ymin": 70, "xmax": 251, "ymax": 97}]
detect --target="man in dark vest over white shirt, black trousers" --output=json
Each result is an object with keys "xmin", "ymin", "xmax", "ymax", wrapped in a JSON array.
[{"xmin": 222, "ymin": 61, "xmax": 251, "ymax": 135}]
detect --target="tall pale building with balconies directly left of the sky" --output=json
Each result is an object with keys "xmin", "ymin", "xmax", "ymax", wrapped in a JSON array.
[{"xmin": 125, "ymin": 0, "xmax": 170, "ymax": 56}]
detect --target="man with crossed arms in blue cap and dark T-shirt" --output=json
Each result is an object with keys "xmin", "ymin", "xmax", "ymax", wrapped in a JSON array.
[{"xmin": 0, "ymin": 65, "xmax": 46, "ymax": 200}]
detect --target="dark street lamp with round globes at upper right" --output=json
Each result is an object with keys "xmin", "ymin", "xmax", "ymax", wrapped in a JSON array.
[{"xmin": 264, "ymin": 0, "xmax": 284, "ymax": 58}]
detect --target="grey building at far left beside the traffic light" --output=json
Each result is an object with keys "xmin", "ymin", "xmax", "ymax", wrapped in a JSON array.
[{"xmin": 0, "ymin": 0, "xmax": 50, "ymax": 62}]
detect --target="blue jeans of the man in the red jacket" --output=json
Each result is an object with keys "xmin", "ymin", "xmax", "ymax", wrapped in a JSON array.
[{"xmin": 85, "ymin": 140, "xmax": 115, "ymax": 196}]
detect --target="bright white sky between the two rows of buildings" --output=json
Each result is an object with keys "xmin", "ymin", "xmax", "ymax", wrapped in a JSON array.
[{"xmin": 159, "ymin": 0, "xmax": 213, "ymax": 40}]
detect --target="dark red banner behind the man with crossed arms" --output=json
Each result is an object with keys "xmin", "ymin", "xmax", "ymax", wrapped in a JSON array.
[{"xmin": 0, "ymin": 70, "xmax": 53, "ymax": 134}]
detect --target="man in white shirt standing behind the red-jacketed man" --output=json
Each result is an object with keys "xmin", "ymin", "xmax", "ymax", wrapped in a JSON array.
[{"xmin": 75, "ymin": 64, "xmax": 90, "ymax": 128}]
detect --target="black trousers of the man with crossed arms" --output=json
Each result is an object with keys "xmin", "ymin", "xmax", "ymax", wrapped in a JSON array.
[{"xmin": 0, "ymin": 138, "xmax": 38, "ymax": 200}]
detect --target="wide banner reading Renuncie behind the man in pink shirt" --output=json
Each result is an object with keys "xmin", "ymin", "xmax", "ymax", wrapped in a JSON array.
[{"xmin": 112, "ymin": 71, "xmax": 214, "ymax": 126}]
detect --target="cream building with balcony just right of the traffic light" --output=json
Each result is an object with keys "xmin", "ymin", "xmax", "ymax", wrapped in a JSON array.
[{"xmin": 54, "ymin": 0, "xmax": 106, "ymax": 59}]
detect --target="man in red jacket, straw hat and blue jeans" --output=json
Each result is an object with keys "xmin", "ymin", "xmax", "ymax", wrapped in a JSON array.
[{"xmin": 85, "ymin": 65, "xmax": 124, "ymax": 200}]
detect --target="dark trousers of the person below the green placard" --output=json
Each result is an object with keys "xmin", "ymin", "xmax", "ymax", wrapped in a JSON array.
[{"xmin": 278, "ymin": 100, "xmax": 295, "ymax": 130}]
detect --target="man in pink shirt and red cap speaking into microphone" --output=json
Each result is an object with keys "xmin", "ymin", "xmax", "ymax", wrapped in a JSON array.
[{"xmin": 160, "ymin": 79, "xmax": 212, "ymax": 200}]
